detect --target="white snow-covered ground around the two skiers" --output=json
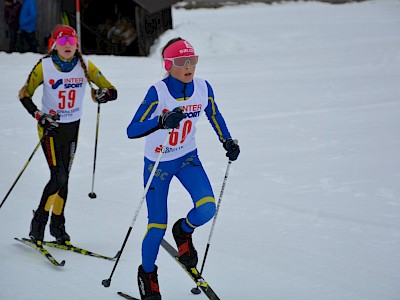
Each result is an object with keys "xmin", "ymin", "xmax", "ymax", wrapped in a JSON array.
[{"xmin": 0, "ymin": 0, "xmax": 400, "ymax": 300}]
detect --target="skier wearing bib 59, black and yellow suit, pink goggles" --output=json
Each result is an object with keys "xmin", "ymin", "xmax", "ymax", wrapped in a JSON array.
[{"xmin": 19, "ymin": 25, "xmax": 117, "ymax": 244}]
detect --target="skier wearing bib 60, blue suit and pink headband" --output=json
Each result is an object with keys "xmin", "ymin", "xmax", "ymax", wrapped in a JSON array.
[{"xmin": 127, "ymin": 38, "xmax": 240, "ymax": 300}]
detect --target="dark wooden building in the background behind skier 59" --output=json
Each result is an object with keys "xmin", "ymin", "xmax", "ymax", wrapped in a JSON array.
[{"xmin": 0, "ymin": 0, "xmax": 178, "ymax": 56}]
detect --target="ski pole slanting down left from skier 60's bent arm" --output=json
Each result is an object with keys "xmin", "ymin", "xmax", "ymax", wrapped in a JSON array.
[{"xmin": 101, "ymin": 130, "xmax": 172, "ymax": 287}]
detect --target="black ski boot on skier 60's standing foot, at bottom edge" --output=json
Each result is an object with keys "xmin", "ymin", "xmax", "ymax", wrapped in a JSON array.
[{"xmin": 138, "ymin": 265, "xmax": 161, "ymax": 300}]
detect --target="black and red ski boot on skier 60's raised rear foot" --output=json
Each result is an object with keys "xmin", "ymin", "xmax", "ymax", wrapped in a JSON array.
[{"xmin": 172, "ymin": 219, "xmax": 198, "ymax": 270}]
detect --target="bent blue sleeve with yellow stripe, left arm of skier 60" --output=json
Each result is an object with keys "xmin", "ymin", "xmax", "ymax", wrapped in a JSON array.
[{"xmin": 126, "ymin": 86, "xmax": 160, "ymax": 139}]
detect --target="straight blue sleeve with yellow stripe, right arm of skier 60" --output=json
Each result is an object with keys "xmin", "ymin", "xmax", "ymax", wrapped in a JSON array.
[{"xmin": 204, "ymin": 81, "xmax": 231, "ymax": 143}]
